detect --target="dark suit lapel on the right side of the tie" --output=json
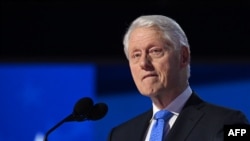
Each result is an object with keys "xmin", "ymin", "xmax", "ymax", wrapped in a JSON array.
[{"xmin": 166, "ymin": 93, "xmax": 204, "ymax": 141}]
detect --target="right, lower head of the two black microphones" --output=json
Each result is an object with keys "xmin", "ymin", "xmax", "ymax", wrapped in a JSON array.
[{"xmin": 88, "ymin": 103, "xmax": 108, "ymax": 120}]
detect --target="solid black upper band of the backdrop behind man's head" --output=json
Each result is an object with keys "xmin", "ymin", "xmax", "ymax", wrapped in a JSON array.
[{"xmin": 0, "ymin": 0, "xmax": 250, "ymax": 63}]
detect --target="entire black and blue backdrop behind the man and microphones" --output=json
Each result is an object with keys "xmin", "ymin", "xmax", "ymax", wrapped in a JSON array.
[{"xmin": 0, "ymin": 0, "xmax": 250, "ymax": 141}]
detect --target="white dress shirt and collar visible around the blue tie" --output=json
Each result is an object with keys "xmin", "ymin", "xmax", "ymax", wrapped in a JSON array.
[{"xmin": 145, "ymin": 86, "xmax": 192, "ymax": 141}]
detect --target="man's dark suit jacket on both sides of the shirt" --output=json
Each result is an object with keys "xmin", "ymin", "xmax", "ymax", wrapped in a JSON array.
[{"xmin": 108, "ymin": 93, "xmax": 248, "ymax": 141}]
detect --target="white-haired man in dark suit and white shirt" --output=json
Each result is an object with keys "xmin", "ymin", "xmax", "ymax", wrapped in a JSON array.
[{"xmin": 108, "ymin": 15, "xmax": 248, "ymax": 141}]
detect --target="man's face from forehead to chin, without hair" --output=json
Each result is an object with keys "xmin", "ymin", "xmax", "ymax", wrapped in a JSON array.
[{"xmin": 128, "ymin": 28, "xmax": 183, "ymax": 96}]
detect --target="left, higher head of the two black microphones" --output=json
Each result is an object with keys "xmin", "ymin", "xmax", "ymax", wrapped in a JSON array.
[{"xmin": 73, "ymin": 97, "xmax": 94, "ymax": 116}]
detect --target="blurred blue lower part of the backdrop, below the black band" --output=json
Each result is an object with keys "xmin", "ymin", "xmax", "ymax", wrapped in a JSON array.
[{"xmin": 0, "ymin": 63, "xmax": 250, "ymax": 141}]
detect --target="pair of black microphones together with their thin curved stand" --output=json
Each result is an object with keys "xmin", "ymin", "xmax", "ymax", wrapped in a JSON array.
[{"xmin": 44, "ymin": 97, "xmax": 108, "ymax": 141}]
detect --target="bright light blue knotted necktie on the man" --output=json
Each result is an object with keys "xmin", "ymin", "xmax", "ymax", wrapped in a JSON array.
[{"xmin": 149, "ymin": 110, "xmax": 172, "ymax": 141}]
